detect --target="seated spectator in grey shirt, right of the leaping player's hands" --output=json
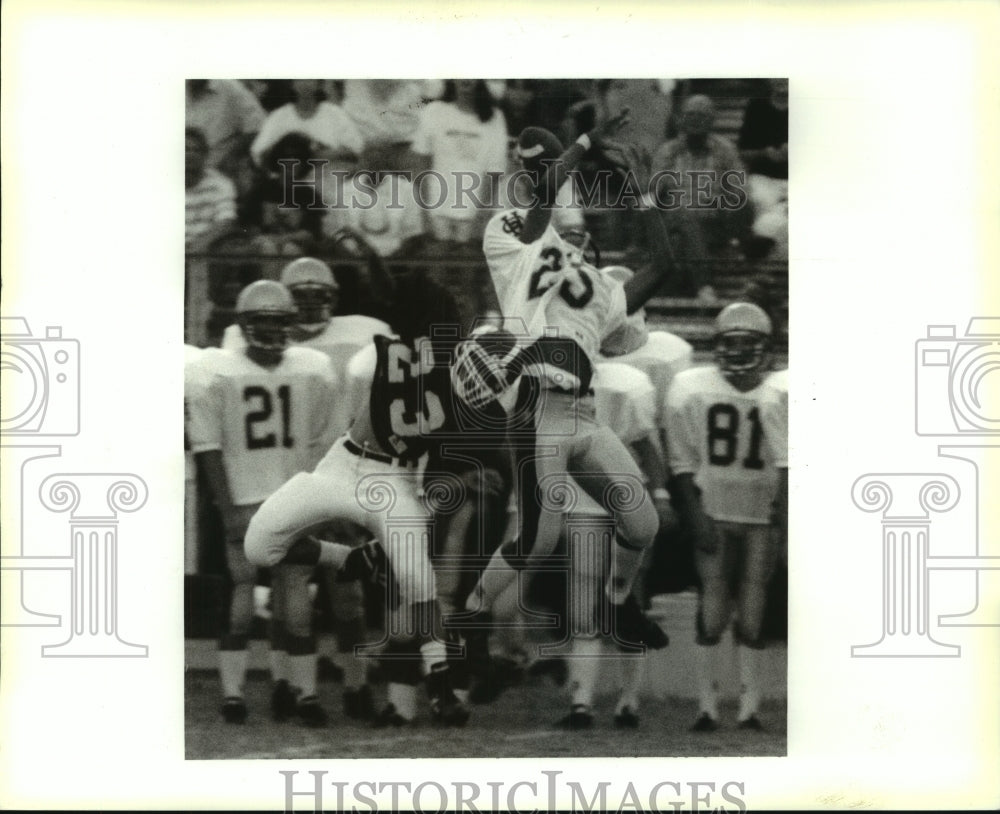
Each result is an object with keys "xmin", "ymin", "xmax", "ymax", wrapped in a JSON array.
[{"xmin": 653, "ymin": 94, "xmax": 750, "ymax": 300}]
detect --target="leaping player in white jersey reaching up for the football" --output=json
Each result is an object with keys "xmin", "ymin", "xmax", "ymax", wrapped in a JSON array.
[{"xmin": 459, "ymin": 122, "xmax": 673, "ymax": 647}]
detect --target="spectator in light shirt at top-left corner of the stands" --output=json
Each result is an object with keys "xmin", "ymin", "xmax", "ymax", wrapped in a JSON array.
[{"xmin": 184, "ymin": 79, "xmax": 264, "ymax": 181}]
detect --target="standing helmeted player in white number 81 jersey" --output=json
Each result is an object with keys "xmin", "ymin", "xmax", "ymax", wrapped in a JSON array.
[{"xmin": 667, "ymin": 302, "xmax": 788, "ymax": 731}]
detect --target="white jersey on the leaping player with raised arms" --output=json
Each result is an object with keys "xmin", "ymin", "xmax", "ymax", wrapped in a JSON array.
[{"xmin": 483, "ymin": 209, "xmax": 626, "ymax": 363}]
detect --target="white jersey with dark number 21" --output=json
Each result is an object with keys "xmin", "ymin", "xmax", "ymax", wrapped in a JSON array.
[{"xmin": 188, "ymin": 347, "xmax": 335, "ymax": 506}]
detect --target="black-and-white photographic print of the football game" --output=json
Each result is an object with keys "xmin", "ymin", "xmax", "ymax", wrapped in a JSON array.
[{"xmin": 184, "ymin": 73, "xmax": 789, "ymax": 758}]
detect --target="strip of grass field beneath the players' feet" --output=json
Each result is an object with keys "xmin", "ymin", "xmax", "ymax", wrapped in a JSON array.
[{"xmin": 185, "ymin": 670, "xmax": 787, "ymax": 760}]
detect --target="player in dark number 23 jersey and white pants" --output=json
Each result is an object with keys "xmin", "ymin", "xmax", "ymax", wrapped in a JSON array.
[{"xmin": 246, "ymin": 274, "xmax": 469, "ymax": 726}]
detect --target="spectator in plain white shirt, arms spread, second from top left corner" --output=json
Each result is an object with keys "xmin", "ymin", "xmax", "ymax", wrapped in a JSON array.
[{"xmin": 250, "ymin": 79, "xmax": 364, "ymax": 170}]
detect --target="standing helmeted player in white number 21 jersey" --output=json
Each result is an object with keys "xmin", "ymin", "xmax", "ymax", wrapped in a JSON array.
[{"xmin": 188, "ymin": 280, "xmax": 334, "ymax": 726}]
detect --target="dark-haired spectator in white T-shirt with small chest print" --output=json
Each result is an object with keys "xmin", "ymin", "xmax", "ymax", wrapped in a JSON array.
[{"xmin": 412, "ymin": 79, "xmax": 507, "ymax": 246}]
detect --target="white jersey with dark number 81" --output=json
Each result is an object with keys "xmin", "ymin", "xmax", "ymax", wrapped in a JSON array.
[{"xmin": 667, "ymin": 366, "xmax": 788, "ymax": 523}]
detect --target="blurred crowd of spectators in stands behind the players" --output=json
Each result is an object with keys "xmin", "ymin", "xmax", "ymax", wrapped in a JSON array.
[{"xmin": 185, "ymin": 79, "xmax": 788, "ymax": 344}]
